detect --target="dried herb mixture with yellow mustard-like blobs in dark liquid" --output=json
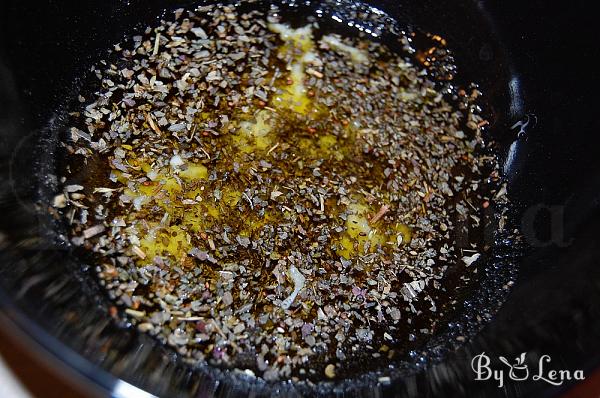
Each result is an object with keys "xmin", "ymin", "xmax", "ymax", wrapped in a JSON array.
[{"xmin": 54, "ymin": 5, "xmax": 506, "ymax": 380}]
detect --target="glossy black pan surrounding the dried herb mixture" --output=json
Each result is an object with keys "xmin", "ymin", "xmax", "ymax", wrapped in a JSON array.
[{"xmin": 0, "ymin": 0, "xmax": 600, "ymax": 397}]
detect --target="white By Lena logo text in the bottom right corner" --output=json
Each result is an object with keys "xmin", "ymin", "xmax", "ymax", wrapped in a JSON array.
[{"xmin": 471, "ymin": 352, "xmax": 585, "ymax": 388}]
